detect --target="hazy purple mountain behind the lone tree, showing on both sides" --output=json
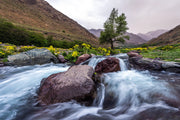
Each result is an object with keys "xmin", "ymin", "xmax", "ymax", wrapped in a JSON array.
[{"xmin": 89, "ymin": 29, "xmax": 147, "ymax": 45}]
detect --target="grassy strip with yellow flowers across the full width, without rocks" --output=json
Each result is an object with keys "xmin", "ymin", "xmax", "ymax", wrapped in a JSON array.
[{"xmin": 0, "ymin": 42, "xmax": 180, "ymax": 62}]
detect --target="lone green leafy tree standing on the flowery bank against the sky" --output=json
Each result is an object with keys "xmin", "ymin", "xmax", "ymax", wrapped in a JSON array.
[{"xmin": 99, "ymin": 8, "xmax": 129, "ymax": 49}]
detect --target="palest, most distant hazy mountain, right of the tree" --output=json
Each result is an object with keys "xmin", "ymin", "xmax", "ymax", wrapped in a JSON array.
[{"xmin": 137, "ymin": 29, "xmax": 168, "ymax": 41}]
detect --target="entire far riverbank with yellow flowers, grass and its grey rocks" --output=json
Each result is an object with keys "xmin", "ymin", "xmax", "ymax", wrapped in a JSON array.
[{"xmin": 0, "ymin": 43, "xmax": 180, "ymax": 73}]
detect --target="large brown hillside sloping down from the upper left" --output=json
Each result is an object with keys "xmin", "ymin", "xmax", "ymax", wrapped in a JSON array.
[{"xmin": 0, "ymin": 0, "xmax": 98, "ymax": 45}]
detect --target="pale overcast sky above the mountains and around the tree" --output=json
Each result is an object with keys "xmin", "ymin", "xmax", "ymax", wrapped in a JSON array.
[{"xmin": 46, "ymin": 0, "xmax": 180, "ymax": 33}]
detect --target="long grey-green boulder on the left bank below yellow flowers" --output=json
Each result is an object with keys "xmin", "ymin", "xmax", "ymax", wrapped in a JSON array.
[{"xmin": 6, "ymin": 48, "xmax": 58, "ymax": 66}]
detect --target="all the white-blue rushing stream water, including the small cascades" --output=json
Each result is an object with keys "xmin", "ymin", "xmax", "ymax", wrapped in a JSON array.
[{"xmin": 0, "ymin": 55, "xmax": 180, "ymax": 120}]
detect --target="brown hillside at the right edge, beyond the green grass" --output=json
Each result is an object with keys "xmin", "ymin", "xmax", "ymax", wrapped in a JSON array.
[{"xmin": 148, "ymin": 25, "xmax": 180, "ymax": 45}]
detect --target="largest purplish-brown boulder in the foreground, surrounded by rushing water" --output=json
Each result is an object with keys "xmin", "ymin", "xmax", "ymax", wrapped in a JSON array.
[{"xmin": 38, "ymin": 65, "xmax": 95, "ymax": 105}]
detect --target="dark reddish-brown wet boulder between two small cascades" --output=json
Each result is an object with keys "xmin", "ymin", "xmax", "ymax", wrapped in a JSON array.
[{"xmin": 95, "ymin": 57, "xmax": 120, "ymax": 74}]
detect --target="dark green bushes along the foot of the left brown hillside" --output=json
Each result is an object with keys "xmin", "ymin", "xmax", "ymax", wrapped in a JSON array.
[{"xmin": 0, "ymin": 19, "xmax": 86, "ymax": 49}]
